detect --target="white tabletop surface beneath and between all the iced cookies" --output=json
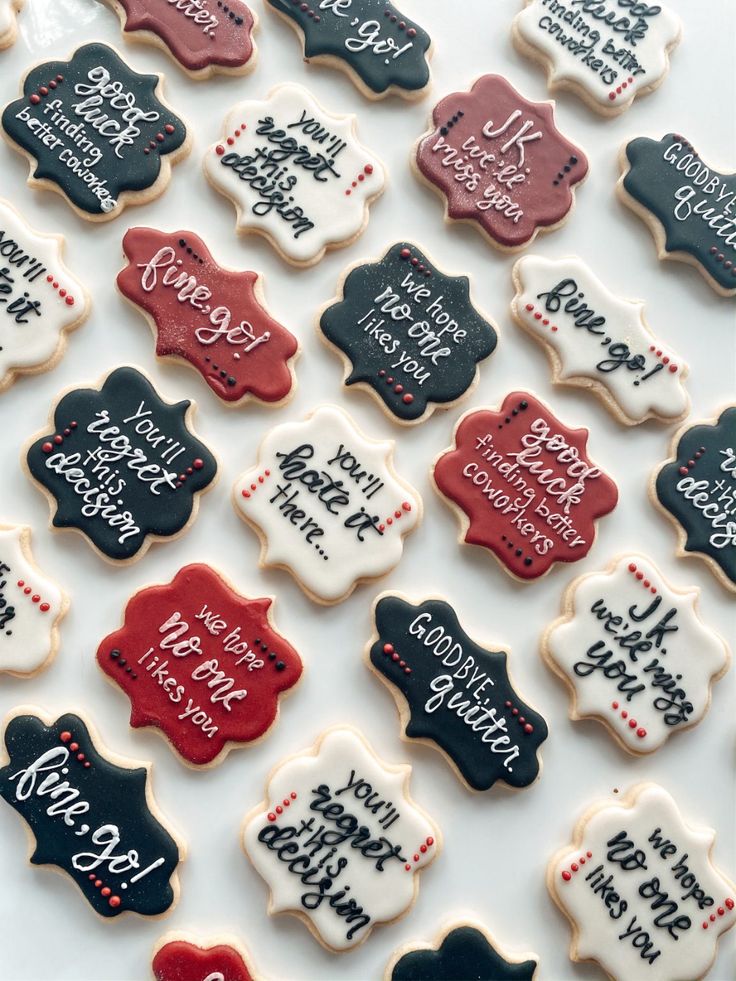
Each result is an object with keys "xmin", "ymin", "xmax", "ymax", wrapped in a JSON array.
[{"xmin": 0, "ymin": 0, "xmax": 736, "ymax": 981}]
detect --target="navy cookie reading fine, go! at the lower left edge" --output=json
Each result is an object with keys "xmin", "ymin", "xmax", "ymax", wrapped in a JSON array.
[{"xmin": 0, "ymin": 708, "xmax": 184, "ymax": 918}]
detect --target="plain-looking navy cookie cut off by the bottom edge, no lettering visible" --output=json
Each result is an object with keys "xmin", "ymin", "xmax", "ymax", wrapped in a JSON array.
[{"xmin": 383, "ymin": 921, "xmax": 537, "ymax": 981}]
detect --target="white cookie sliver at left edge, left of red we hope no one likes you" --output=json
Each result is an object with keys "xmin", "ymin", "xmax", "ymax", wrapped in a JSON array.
[{"xmin": 0, "ymin": 525, "xmax": 68, "ymax": 677}]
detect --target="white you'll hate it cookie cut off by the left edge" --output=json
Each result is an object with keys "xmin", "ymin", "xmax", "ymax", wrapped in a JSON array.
[{"xmin": 0, "ymin": 197, "xmax": 89, "ymax": 392}]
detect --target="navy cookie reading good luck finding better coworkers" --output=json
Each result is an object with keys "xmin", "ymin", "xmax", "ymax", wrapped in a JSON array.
[{"xmin": 2, "ymin": 43, "xmax": 189, "ymax": 221}]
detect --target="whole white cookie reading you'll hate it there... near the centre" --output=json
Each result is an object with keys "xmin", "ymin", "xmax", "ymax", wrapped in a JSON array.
[{"xmin": 233, "ymin": 405, "xmax": 422, "ymax": 603}]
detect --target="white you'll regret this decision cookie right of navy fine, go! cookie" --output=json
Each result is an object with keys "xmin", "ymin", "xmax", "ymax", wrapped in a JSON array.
[{"xmin": 243, "ymin": 727, "xmax": 440, "ymax": 952}]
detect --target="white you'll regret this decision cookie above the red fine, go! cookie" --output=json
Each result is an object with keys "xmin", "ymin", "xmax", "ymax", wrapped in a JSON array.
[{"xmin": 204, "ymin": 84, "xmax": 385, "ymax": 266}]
